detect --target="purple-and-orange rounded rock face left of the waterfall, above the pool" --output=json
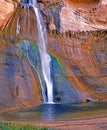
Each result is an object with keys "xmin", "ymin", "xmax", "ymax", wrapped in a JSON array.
[{"xmin": 0, "ymin": 40, "xmax": 41, "ymax": 110}]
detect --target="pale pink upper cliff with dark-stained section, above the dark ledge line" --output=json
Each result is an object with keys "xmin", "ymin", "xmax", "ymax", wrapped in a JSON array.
[{"xmin": 40, "ymin": 0, "xmax": 107, "ymax": 33}]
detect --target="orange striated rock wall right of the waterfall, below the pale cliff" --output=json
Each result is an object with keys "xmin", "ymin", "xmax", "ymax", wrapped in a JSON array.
[{"xmin": 49, "ymin": 31, "xmax": 107, "ymax": 102}]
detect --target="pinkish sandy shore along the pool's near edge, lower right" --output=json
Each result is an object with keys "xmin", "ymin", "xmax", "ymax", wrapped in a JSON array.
[{"xmin": 33, "ymin": 117, "xmax": 107, "ymax": 130}]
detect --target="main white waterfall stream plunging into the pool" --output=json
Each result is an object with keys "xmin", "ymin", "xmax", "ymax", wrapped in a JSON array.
[{"xmin": 21, "ymin": 0, "xmax": 53, "ymax": 103}]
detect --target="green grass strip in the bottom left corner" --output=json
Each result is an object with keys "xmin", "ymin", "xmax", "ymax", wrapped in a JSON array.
[{"xmin": 0, "ymin": 122, "xmax": 52, "ymax": 130}]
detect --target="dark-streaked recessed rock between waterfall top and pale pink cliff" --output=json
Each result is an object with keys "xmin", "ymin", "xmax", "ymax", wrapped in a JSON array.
[{"xmin": 39, "ymin": 0, "xmax": 64, "ymax": 33}]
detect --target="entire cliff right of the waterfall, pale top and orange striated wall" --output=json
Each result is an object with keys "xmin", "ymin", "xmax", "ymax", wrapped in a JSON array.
[{"xmin": 44, "ymin": 0, "xmax": 107, "ymax": 101}]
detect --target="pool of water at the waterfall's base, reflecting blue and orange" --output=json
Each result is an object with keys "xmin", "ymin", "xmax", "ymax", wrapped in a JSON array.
[{"xmin": 0, "ymin": 103, "xmax": 107, "ymax": 121}]
